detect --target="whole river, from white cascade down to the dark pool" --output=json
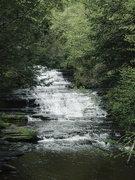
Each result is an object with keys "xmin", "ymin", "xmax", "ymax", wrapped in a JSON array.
[{"xmin": 1, "ymin": 67, "xmax": 135, "ymax": 180}]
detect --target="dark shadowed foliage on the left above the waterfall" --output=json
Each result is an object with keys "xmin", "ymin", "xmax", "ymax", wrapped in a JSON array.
[{"xmin": 0, "ymin": 0, "xmax": 61, "ymax": 94}]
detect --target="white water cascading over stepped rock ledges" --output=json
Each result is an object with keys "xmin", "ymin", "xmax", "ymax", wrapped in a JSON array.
[{"xmin": 26, "ymin": 68, "xmax": 112, "ymax": 150}]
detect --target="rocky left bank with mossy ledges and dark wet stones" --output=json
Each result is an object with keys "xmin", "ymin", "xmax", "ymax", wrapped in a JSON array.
[{"xmin": 0, "ymin": 113, "xmax": 38, "ymax": 172}]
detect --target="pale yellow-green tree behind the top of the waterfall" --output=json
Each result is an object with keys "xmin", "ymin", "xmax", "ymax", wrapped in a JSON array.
[{"xmin": 51, "ymin": 1, "xmax": 93, "ymax": 84}]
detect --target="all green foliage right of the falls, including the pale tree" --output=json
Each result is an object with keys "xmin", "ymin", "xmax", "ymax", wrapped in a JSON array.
[{"xmin": 51, "ymin": 0, "xmax": 135, "ymax": 132}]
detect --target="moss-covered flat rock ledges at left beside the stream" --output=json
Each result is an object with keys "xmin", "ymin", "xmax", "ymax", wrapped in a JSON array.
[{"xmin": 0, "ymin": 113, "xmax": 37, "ymax": 142}]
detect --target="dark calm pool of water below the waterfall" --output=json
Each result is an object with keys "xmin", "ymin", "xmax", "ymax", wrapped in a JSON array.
[{"xmin": 1, "ymin": 150, "xmax": 135, "ymax": 180}]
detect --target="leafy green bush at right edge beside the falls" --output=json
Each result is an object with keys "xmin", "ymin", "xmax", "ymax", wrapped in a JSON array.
[{"xmin": 106, "ymin": 67, "xmax": 135, "ymax": 130}]
